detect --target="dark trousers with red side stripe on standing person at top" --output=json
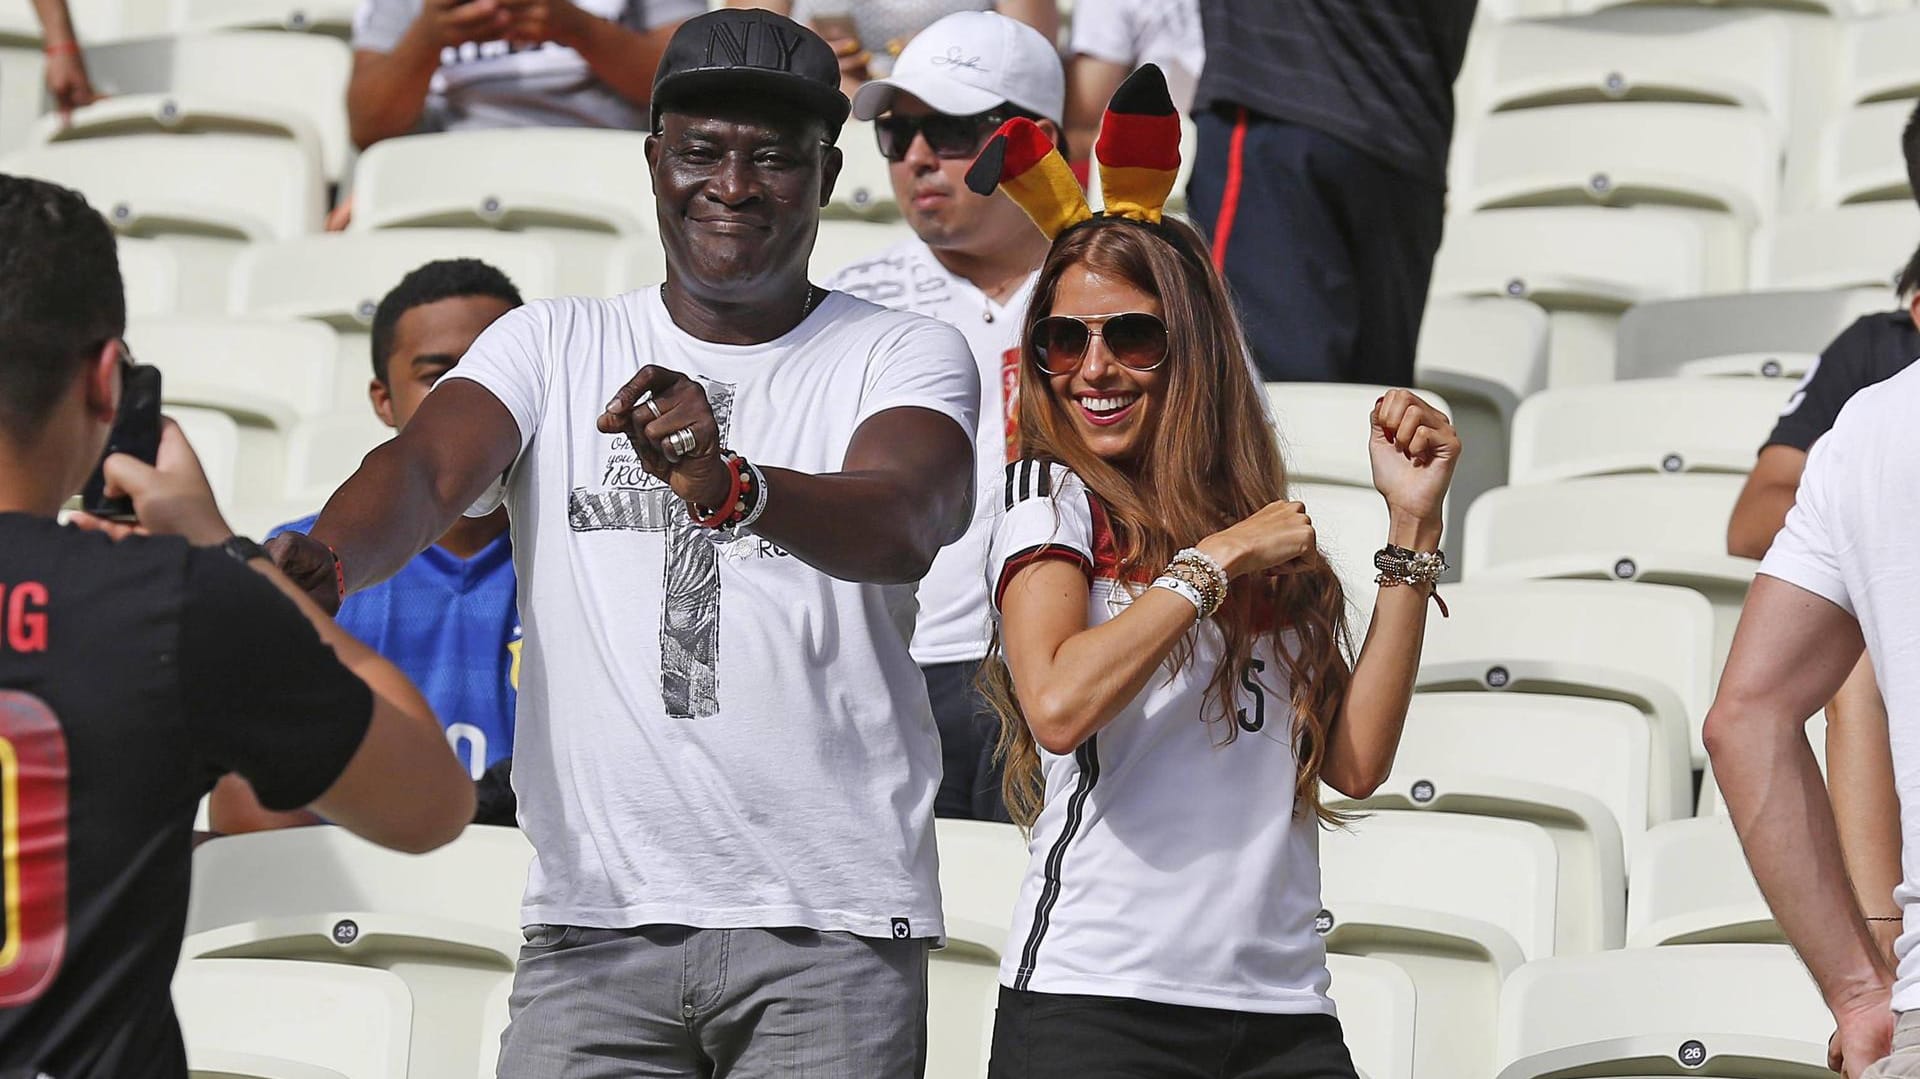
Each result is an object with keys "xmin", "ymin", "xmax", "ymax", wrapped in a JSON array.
[{"xmin": 1187, "ymin": 109, "xmax": 1446, "ymax": 386}]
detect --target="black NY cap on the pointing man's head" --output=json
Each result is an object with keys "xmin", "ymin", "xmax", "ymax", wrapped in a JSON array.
[{"xmin": 649, "ymin": 8, "xmax": 851, "ymax": 136}]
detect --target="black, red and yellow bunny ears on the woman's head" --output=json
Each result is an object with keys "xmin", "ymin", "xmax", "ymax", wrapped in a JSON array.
[{"xmin": 966, "ymin": 63, "xmax": 1181, "ymax": 240}]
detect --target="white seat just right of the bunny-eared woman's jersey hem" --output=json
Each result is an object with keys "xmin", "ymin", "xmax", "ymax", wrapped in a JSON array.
[{"xmin": 1319, "ymin": 810, "xmax": 1557, "ymax": 1075}]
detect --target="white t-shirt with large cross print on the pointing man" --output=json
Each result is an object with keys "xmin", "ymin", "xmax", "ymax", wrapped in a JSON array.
[{"xmin": 447, "ymin": 288, "xmax": 979, "ymax": 937}]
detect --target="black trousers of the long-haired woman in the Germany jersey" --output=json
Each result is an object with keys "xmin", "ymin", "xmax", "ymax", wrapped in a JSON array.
[{"xmin": 987, "ymin": 987, "xmax": 1356, "ymax": 1079}]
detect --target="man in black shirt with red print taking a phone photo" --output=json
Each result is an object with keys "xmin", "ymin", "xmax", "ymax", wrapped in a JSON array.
[{"xmin": 0, "ymin": 175, "xmax": 474, "ymax": 1079}]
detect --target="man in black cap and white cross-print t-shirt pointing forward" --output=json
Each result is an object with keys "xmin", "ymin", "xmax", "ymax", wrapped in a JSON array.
[{"xmin": 276, "ymin": 10, "xmax": 979, "ymax": 1079}]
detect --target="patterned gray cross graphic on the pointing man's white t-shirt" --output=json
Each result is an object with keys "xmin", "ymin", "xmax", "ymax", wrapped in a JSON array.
[{"xmin": 566, "ymin": 378, "xmax": 733, "ymax": 720}]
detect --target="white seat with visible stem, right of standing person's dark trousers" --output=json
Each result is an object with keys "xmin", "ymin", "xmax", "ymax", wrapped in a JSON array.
[{"xmin": 1432, "ymin": 205, "xmax": 1720, "ymax": 386}]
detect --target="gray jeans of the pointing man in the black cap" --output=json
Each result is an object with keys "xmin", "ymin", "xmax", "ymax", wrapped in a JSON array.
[{"xmin": 499, "ymin": 913, "xmax": 927, "ymax": 1079}]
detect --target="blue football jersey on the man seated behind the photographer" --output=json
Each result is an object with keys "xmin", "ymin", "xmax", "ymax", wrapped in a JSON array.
[{"xmin": 271, "ymin": 516, "xmax": 520, "ymax": 779}]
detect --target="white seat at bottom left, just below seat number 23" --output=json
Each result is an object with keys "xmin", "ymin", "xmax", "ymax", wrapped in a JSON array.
[{"xmin": 173, "ymin": 960, "xmax": 412, "ymax": 1079}]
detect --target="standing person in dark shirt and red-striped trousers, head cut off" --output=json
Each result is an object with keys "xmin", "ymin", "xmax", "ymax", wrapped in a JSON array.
[{"xmin": 1187, "ymin": 0, "xmax": 1475, "ymax": 386}]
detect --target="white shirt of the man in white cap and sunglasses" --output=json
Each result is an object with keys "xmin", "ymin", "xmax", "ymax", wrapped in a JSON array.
[{"xmin": 828, "ymin": 238, "xmax": 1039, "ymax": 666}]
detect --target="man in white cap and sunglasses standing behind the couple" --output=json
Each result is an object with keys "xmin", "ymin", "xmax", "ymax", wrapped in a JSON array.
[{"xmin": 828, "ymin": 12, "xmax": 1066, "ymax": 820}]
